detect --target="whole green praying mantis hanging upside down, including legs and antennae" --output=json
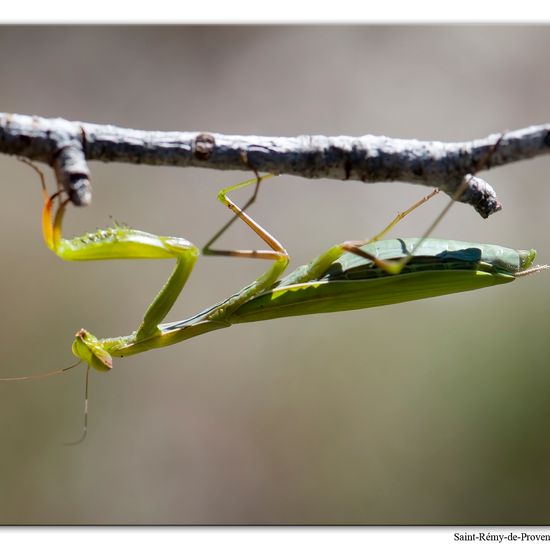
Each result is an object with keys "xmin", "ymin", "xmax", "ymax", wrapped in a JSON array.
[{"xmin": 1, "ymin": 162, "xmax": 547, "ymax": 444}]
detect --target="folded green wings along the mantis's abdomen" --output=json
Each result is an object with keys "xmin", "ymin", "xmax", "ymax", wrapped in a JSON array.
[{"xmin": 231, "ymin": 238, "xmax": 535, "ymax": 323}]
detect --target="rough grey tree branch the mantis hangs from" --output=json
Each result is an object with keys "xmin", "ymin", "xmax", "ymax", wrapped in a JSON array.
[{"xmin": 0, "ymin": 113, "xmax": 550, "ymax": 217}]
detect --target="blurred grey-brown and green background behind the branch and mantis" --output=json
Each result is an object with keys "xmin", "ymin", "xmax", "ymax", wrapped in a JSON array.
[{"xmin": 0, "ymin": 26, "xmax": 550, "ymax": 525}]
